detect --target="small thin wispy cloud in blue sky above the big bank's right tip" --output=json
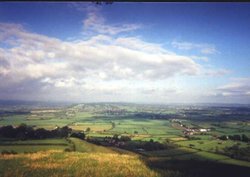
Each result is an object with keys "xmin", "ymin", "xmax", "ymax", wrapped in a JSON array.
[{"xmin": 171, "ymin": 41, "xmax": 217, "ymax": 54}]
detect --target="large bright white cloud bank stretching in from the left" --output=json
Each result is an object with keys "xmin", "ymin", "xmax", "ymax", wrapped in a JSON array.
[{"xmin": 0, "ymin": 19, "xmax": 204, "ymax": 101}]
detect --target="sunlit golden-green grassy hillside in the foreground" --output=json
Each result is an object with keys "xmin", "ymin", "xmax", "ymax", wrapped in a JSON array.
[{"xmin": 0, "ymin": 138, "xmax": 159, "ymax": 177}]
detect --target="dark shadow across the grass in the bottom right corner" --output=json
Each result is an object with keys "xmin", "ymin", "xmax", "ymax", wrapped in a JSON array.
[{"xmin": 146, "ymin": 158, "xmax": 250, "ymax": 177}]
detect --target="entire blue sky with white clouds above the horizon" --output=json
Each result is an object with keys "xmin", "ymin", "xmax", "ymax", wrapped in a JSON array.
[{"xmin": 0, "ymin": 2, "xmax": 250, "ymax": 104}]
